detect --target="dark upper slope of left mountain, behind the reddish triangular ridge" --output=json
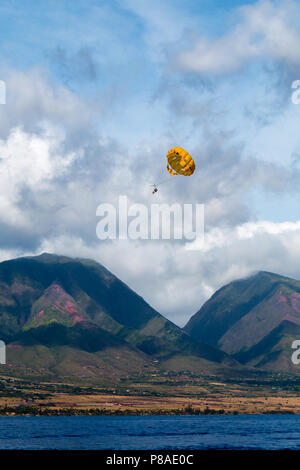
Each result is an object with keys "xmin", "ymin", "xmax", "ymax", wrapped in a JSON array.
[{"xmin": 0, "ymin": 254, "xmax": 157, "ymax": 334}]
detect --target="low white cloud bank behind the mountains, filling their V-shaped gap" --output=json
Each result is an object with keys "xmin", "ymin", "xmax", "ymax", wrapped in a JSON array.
[{"xmin": 20, "ymin": 217, "xmax": 300, "ymax": 326}]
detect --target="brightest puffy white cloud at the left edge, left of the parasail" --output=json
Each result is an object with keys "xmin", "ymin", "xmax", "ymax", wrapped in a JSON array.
[{"xmin": 0, "ymin": 123, "xmax": 78, "ymax": 227}]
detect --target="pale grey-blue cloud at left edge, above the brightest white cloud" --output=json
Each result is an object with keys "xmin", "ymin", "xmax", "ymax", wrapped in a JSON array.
[{"xmin": 0, "ymin": 67, "xmax": 93, "ymax": 137}]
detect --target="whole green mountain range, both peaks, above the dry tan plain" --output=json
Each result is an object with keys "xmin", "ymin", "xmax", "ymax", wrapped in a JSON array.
[{"xmin": 0, "ymin": 253, "xmax": 300, "ymax": 380}]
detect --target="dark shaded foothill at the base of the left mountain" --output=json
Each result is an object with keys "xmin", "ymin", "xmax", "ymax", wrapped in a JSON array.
[{"xmin": 1, "ymin": 322, "xmax": 153, "ymax": 380}]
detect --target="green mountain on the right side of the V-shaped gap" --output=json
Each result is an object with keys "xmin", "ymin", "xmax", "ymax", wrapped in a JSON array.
[{"xmin": 184, "ymin": 272, "xmax": 300, "ymax": 369}]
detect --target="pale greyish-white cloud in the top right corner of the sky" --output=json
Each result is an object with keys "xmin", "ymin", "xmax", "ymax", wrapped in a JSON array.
[{"xmin": 177, "ymin": 0, "xmax": 300, "ymax": 74}]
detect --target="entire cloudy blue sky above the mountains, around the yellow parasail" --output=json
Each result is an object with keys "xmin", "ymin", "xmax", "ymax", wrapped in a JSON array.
[{"xmin": 0, "ymin": 0, "xmax": 300, "ymax": 324}]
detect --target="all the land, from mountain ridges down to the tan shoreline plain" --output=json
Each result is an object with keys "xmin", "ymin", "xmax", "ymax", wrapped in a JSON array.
[{"xmin": 0, "ymin": 253, "xmax": 300, "ymax": 414}]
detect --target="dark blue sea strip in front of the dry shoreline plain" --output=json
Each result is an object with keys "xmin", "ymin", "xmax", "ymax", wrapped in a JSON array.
[{"xmin": 0, "ymin": 415, "xmax": 300, "ymax": 450}]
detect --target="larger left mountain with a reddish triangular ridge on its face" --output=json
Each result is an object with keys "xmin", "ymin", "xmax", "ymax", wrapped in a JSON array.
[{"xmin": 0, "ymin": 254, "xmax": 237, "ymax": 375}]
